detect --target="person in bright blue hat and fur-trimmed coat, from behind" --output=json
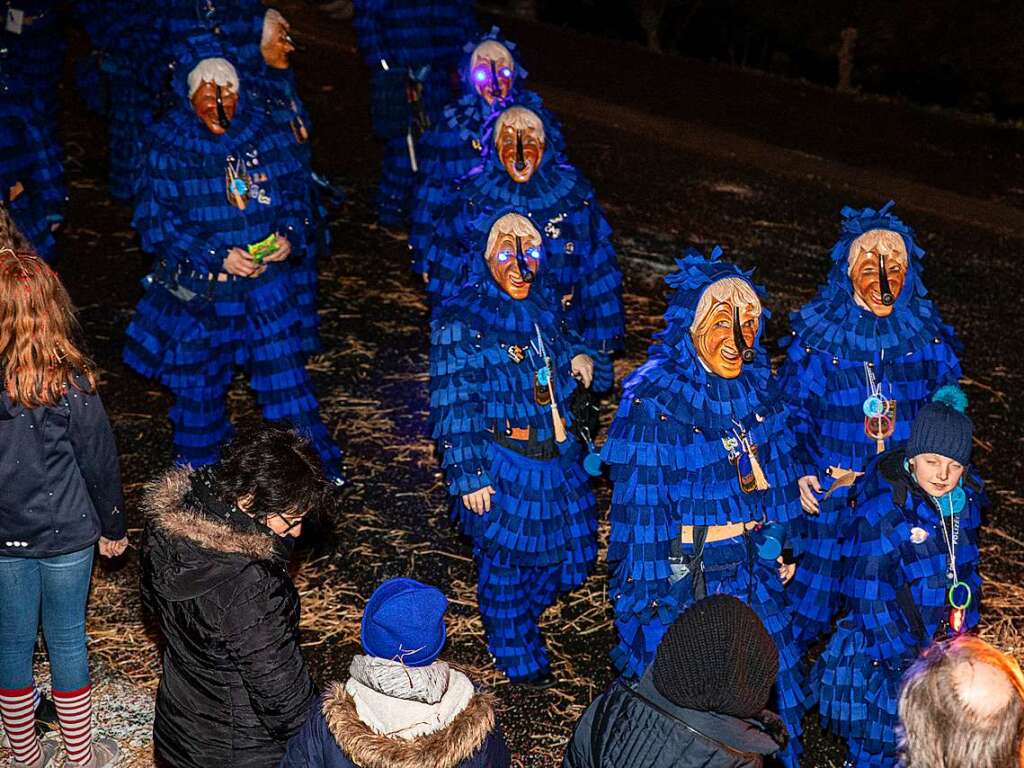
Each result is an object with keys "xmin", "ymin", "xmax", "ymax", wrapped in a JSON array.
[{"xmin": 280, "ymin": 579, "xmax": 510, "ymax": 768}]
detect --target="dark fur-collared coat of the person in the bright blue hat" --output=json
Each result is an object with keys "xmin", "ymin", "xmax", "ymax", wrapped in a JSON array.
[{"xmin": 281, "ymin": 683, "xmax": 512, "ymax": 768}]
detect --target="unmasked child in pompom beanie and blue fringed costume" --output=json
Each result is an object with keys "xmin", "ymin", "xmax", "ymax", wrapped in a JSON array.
[{"xmin": 812, "ymin": 386, "xmax": 985, "ymax": 768}]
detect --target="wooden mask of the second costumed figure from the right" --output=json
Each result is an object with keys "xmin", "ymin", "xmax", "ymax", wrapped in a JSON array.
[{"xmin": 690, "ymin": 278, "xmax": 761, "ymax": 379}]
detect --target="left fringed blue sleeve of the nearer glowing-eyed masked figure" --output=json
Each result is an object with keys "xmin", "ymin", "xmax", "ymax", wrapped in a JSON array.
[{"xmin": 430, "ymin": 321, "xmax": 494, "ymax": 497}]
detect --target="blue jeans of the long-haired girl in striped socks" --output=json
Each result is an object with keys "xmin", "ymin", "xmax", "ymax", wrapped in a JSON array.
[{"xmin": 0, "ymin": 547, "xmax": 94, "ymax": 691}]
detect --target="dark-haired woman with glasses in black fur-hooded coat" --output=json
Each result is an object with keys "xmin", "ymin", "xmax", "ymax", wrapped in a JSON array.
[{"xmin": 142, "ymin": 427, "xmax": 327, "ymax": 768}]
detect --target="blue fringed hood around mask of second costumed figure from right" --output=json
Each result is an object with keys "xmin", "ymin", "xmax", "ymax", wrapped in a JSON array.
[{"xmin": 655, "ymin": 246, "xmax": 771, "ymax": 359}]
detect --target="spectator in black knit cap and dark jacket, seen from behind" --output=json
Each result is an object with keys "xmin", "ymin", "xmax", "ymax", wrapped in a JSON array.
[{"xmin": 562, "ymin": 595, "xmax": 788, "ymax": 768}]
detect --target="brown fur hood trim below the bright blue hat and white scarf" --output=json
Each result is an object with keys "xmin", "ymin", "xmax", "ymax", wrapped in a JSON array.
[{"xmin": 323, "ymin": 683, "xmax": 496, "ymax": 768}]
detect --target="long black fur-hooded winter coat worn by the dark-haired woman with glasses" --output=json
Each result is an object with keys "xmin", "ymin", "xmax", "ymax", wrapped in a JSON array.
[{"xmin": 142, "ymin": 469, "xmax": 316, "ymax": 768}]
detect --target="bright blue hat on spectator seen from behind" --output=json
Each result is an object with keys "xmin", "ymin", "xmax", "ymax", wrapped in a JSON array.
[{"xmin": 361, "ymin": 579, "xmax": 447, "ymax": 667}]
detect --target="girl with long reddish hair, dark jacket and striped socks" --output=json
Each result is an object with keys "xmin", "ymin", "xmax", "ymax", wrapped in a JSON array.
[{"xmin": 0, "ymin": 249, "xmax": 128, "ymax": 768}]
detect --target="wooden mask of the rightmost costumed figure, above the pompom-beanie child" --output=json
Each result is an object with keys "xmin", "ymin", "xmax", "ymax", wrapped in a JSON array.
[{"xmin": 847, "ymin": 229, "xmax": 907, "ymax": 317}]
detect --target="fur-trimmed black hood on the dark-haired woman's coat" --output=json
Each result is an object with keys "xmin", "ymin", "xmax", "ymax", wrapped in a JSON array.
[{"xmin": 142, "ymin": 468, "xmax": 284, "ymax": 600}]
